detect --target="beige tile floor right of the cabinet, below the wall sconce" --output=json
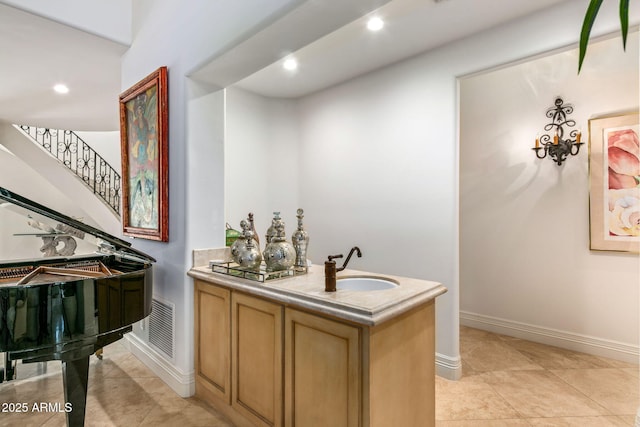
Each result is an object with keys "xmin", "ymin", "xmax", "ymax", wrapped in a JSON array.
[{"xmin": 436, "ymin": 327, "xmax": 640, "ymax": 427}]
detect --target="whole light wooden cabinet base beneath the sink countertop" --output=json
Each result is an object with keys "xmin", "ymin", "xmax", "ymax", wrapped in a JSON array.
[{"xmin": 194, "ymin": 280, "xmax": 435, "ymax": 427}]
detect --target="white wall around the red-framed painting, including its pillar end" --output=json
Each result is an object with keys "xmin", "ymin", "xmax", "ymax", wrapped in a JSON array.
[{"xmin": 122, "ymin": 0, "xmax": 308, "ymax": 395}]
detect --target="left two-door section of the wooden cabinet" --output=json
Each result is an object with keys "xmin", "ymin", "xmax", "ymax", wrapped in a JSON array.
[{"xmin": 194, "ymin": 280, "xmax": 284, "ymax": 426}]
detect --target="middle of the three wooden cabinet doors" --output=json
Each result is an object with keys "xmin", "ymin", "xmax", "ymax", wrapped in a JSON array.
[{"xmin": 231, "ymin": 292, "xmax": 283, "ymax": 426}]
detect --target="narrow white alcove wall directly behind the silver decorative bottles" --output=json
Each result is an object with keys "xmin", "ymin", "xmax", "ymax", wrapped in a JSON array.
[{"xmin": 224, "ymin": 87, "xmax": 302, "ymax": 237}]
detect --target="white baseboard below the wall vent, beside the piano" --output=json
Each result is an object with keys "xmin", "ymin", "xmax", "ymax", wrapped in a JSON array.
[{"xmin": 123, "ymin": 334, "xmax": 196, "ymax": 397}]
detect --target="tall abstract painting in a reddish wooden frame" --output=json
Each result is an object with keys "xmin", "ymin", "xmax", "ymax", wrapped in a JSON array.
[{"xmin": 120, "ymin": 67, "xmax": 169, "ymax": 242}]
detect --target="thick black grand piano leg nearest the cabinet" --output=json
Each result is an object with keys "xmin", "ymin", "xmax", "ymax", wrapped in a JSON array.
[{"xmin": 62, "ymin": 356, "xmax": 89, "ymax": 427}]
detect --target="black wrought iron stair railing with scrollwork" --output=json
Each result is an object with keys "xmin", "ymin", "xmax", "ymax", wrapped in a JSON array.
[{"xmin": 19, "ymin": 125, "xmax": 121, "ymax": 216}]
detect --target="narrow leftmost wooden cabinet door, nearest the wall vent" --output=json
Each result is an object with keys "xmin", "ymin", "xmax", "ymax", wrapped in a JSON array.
[{"xmin": 194, "ymin": 280, "xmax": 231, "ymax": 404}]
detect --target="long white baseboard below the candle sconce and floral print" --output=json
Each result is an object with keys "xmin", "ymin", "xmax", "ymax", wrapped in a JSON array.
[{"xmin": 460, "ymin": 311, "xmax": 640, "ymax": 364}]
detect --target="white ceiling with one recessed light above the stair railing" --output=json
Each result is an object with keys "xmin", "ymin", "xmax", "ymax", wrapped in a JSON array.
[{"xmin": 0, "ymin": 4, "xmax": 128, "ymax": 131}]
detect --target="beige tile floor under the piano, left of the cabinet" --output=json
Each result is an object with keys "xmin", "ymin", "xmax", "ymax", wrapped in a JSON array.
[{"xmin": 0, "ymin": 341, "xmax": 233, "ymax": 427}]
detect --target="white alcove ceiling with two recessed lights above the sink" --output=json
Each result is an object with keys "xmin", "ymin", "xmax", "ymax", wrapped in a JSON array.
[{"xmin": 230, "ymin": 0, "xmax": 564, "ymax": 97}]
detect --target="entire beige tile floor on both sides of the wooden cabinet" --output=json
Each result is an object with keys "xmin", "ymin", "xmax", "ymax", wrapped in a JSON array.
[{"xmin": 0, "ymin": 327, "xmax": 640, "ymax": 427}]
